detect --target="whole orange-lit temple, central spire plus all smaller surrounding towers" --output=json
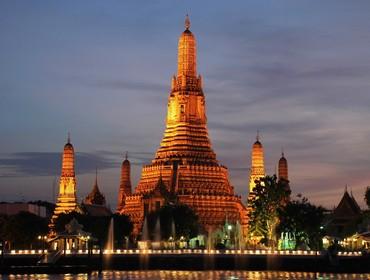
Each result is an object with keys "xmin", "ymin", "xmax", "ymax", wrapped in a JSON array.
[{"xmin": 49, "ymin": 17, "xmax": 288, "ymax": 236}]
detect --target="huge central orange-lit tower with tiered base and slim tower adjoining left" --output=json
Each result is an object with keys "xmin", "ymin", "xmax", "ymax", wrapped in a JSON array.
[{"xmin": 118, "ymin": 17, "xmax": 248, "ymax": 235}]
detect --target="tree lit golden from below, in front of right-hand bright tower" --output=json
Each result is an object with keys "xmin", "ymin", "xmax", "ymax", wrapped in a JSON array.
[{"xmin": 248, "ymin": 175, "xmax": 291, "ymax": 247}]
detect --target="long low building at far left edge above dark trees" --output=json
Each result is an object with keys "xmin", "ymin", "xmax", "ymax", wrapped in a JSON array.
[{"xmin": 0, "ymin": 202, "xmax": 48, "ymax": 218}]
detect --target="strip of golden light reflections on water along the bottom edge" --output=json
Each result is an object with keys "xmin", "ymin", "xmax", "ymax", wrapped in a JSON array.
[{"xmin": 0, "ymin": 270, "xmax": 370, "ymax": 280}]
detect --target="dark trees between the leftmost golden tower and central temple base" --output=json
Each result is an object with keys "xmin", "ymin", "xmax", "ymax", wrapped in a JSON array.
[{"xmin": 55, "ymin": 212, "xmax": 133, "ymax": 246}]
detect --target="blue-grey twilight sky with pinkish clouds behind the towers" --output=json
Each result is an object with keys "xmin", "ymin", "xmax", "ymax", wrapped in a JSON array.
[{"xmin": 0, "ymin": 0, "xmax": 370, "ymax": 208}]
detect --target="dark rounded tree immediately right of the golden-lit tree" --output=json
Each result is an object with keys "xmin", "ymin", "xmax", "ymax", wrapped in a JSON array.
[{"xmin": 278, "ymin": 196, "xmax": 324, "ymax": 249}]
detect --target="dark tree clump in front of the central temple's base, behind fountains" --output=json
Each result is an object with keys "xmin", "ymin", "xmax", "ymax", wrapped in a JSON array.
[{"xmin": 147, "ymin": 204, "xmax": 200, "ymax": 239}]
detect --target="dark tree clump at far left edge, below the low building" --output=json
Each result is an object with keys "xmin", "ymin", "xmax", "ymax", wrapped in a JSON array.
[{"xmin": 0, "ymin": 212, "xmax": 48, "ymax": 249}]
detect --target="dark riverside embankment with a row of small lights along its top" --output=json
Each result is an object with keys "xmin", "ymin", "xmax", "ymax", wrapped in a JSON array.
[{"xmin": 1, "ymin": 250, "xmax": 370, "ymax": 274}]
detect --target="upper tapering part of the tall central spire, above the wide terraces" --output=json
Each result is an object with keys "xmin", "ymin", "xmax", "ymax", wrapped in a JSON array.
[{"xmin": 155, "ymin": 17, "xmax": 218, "ymax": 165}]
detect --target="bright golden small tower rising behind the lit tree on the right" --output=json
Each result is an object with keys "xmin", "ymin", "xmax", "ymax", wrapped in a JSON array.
[{"xmin": 249, "ymin": 132, "xmax": 265, "ymax": 194}]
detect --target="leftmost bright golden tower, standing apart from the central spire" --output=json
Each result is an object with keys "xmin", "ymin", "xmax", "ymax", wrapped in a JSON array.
[{"xmin": 49, "ymin": 135, "xmax": 78, "ymax": 232}]
